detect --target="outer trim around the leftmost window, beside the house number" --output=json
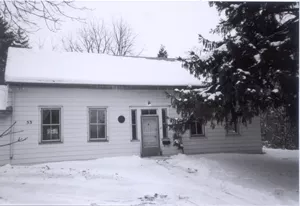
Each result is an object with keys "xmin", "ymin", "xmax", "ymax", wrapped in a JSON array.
[{"xmin": 38, "ymin": 105, "xmax": 64, "ymax": 144}]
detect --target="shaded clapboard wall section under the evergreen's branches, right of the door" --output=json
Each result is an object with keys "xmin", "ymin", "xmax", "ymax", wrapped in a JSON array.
[{"xmin": 183, "ymin": 117, "xmax": 262, "ymax": 154}]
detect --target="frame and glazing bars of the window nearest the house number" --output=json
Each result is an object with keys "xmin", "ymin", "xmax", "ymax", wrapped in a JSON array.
[{"xmin": 39, "ymin": 106, "xmax": 63, "ymax": 144}]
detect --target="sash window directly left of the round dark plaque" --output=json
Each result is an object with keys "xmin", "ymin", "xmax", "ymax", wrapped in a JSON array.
[{"xmin": 89, "ymin": 108, "xmax": 106, "ymax": 141}]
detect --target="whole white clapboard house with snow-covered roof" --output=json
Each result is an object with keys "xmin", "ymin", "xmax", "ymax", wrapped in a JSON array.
[{"xmin": 0, "ymin": 48, "xmax": 262, "ymax": 164}]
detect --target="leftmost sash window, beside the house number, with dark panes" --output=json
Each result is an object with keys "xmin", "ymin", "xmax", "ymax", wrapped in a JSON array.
[{"xmin": 41, "ymin": 108, "xmax": 61, "ymax": 142}]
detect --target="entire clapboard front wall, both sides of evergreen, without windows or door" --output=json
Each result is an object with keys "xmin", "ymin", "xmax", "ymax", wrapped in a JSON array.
[{"xmin": 0, "ymin": 86, "xmax": 262, "ymax": 165}]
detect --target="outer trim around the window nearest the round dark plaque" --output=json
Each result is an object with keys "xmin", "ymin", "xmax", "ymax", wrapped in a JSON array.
[{"xmin": 87, "ymin": 106, "xmax": 108, "ymax": 142}]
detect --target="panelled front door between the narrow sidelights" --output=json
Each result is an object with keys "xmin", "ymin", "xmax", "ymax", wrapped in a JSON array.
[{"xmin": 141, "ymin": 116, "xmax": 160, "ymax": 157}]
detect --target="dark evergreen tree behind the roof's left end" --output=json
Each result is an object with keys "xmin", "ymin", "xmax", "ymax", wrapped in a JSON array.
[{"xmin": 0, "ymin": 17, "xmax": 29, "ymax": 85}]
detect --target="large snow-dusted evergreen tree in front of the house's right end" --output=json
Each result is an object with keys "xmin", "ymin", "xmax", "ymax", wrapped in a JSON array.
[{"xmin": 168, "ymin": 2, "xmax": 299, "ymax": 143}]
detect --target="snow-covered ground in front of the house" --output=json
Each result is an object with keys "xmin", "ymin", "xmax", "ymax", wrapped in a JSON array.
[{"xmin": 0, "ymin": 149, "xmax": 299, "ymax": 206}]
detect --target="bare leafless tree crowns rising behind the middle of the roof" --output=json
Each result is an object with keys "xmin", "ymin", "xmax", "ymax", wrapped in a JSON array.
[{"xmin": 62, "ymin": 19, "xmax": 143, "ymax": 56}]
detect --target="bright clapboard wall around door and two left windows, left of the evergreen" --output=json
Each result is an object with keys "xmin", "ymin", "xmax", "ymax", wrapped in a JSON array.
[{"xmin": 6, "ymin": 86, "xmax": 178, "ymax": 164}]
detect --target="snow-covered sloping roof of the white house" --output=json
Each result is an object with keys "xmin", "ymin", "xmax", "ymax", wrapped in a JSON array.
[{"xmin": 5, "ymin": 47, "xmax": 203, "ymax": 86}]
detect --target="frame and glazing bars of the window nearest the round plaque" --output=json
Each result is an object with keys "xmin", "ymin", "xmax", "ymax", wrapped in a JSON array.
[{"xmin": 87, "ymin": 107, "xmax": 108, "ymax": 142}]
